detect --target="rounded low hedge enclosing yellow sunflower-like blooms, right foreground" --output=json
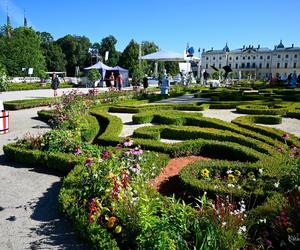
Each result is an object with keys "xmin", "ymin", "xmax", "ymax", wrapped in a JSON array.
[{"xmin": 180, "ymin": 160, "xmax": 277, "ymax": 197}]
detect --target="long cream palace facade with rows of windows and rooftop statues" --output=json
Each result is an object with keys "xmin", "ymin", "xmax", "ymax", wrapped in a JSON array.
[{"xmin": 201, "ymin": 41, "xmax": 300, "ymax": 79}]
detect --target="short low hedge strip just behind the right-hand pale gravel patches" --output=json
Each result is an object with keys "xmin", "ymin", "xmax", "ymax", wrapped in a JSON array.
[{"xmin": 236, "ymin": 105, "xmax": 287, "ymax": 115}]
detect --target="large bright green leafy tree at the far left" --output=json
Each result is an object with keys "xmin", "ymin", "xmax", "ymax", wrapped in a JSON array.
[{"xmin": 0, "ymin": 27, "xmax": 46, "ymax": 76}]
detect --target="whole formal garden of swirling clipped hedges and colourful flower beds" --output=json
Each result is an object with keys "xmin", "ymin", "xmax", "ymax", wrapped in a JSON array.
[{"xmin": 4, "ymin": 85, "xmax": 300, "ymax": 249}]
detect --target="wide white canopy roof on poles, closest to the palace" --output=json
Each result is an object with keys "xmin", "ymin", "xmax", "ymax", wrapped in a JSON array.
[{"xmin": 140, "ymin": 50, "xmax": 200, "ymax": 62}]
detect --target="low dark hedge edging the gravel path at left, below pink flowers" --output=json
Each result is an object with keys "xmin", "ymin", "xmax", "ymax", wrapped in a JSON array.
[{"xmin": 3, "ymin": 143, "xmax": 83, "ymax": 174}]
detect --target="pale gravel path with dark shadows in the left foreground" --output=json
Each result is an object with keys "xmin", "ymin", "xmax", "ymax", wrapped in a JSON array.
[{"xmin": 0, "ymin": 108, "xmax": 85, "ymax": 249}]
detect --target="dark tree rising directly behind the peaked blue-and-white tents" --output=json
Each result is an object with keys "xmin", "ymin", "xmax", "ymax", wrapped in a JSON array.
[{"xmin": 99, "ymin": 35, "xmax": 119, "ymax": 67}]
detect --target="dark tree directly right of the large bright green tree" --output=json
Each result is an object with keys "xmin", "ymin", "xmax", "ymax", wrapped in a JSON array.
[{"xmin": 38, "ymin": 32, "xmax": 67, "ymax": 71}]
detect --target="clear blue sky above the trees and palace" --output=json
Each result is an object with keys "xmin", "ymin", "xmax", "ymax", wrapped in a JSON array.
[{"xmin": 0, "ymin": 0, "xmax": 300, "ymax": 53}]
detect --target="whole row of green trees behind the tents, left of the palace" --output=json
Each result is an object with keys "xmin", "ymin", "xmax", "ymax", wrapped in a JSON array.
[{"xmin": 0, "ymin": 26, "xmax": 179, "ymax": 80}]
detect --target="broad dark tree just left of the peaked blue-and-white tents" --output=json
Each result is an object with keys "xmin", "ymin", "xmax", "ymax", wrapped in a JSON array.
[{"xmin": 57, "ymin": 35, "xmax": 91, "ymax": 76}]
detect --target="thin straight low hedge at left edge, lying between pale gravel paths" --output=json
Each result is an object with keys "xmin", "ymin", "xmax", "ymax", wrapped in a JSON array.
[{"xmin": 3, "ymin": 98, "xmax": 59, "ymax": 110}]
